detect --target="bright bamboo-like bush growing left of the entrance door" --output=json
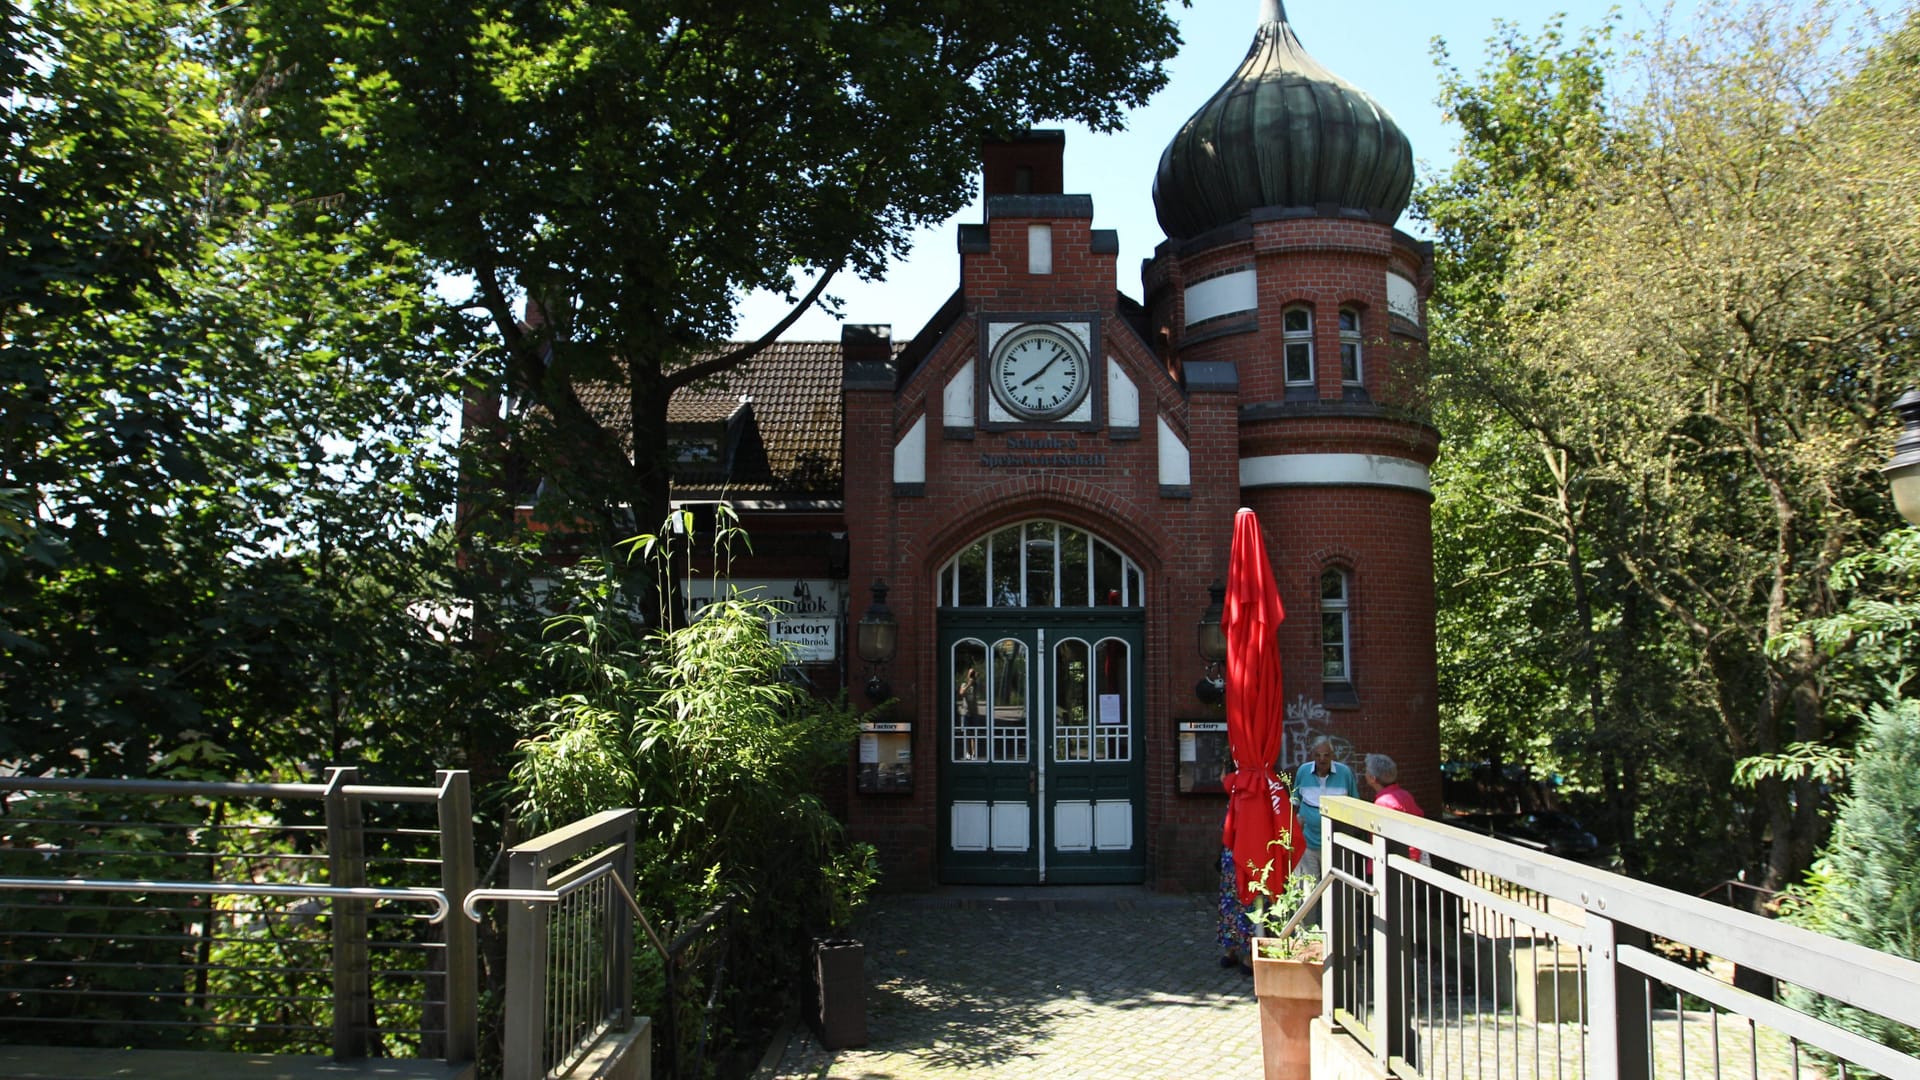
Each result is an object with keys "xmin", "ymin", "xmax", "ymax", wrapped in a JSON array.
[{"xmin": 513, "ymin": 528, "xmax": 877, "ymax": 1042}]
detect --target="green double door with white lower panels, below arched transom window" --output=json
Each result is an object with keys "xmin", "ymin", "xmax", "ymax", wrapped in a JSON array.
[{"xmin": 939, "ymin": 609, "xmax": 1146, "ymax": 884}]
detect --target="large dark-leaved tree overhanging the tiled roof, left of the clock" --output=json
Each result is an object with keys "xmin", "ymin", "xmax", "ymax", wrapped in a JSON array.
[{"xmin": 236, "ymin": 0, "xmax": 1177, "ymax": 618}]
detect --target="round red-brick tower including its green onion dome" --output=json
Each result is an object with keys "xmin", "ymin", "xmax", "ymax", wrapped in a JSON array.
[{"xmin": 1142, "ymin": 0, "xmax": 1440, "ymax": 807}]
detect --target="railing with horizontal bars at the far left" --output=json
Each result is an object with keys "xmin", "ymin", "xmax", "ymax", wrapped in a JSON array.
[{"xmin": 0, "ymin": 769, "xmax": 478, "ymax": 1065}]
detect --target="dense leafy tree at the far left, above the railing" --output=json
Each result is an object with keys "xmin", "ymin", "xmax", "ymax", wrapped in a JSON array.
[{"xmin": 0, "ymin": 0, "xmax": 478, "ymax": 773}]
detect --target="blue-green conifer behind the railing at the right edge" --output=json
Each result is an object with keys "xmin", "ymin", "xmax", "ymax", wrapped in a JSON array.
[{"xmin": 1780, "ymin": 698, "xmax": 1920, "ymax": 1053}]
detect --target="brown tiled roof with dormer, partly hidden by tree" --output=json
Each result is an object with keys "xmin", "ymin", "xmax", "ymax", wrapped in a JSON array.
[{"xmin": 564, "ymin": 342, "xmax": 843, "ymax": 498}]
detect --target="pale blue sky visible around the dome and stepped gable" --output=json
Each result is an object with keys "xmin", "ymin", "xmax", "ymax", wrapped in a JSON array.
[{"xmin": 735, "ymin": 0, "xmax": 1666, "ymax": 340}]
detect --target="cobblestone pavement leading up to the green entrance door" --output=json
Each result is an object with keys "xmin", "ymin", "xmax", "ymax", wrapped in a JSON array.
[{"xmin": 758, "ymin": 888, "xmax": 1260, "ymax": 1080}]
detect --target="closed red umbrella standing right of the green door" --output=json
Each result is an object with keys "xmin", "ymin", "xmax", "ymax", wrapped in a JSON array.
[{"xmin": 1219, "ymin": 507, "xmax": 1308, "ymax": 903}]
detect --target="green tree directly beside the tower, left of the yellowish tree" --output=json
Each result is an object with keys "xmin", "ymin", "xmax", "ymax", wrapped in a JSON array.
[{"xmin": 1413, "ymin": 19, "xmax": 1670, "ymax": 857}]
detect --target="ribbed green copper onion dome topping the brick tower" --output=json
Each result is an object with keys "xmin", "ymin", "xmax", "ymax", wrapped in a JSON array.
[{"xmin": 1154, "ymin": 0, "xmax": 1413, "ymax": 238}]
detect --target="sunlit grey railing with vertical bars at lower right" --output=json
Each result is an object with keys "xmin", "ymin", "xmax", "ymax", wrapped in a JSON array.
[{"xmin": 1319, "ymin": 798, "xmax": 1920, "ymax": 1080}]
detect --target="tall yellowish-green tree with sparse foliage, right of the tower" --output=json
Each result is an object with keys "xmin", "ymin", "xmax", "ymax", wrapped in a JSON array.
[{"xmin": 1420, "ymin": 4, "xmax": 1920, "ymax": 886}]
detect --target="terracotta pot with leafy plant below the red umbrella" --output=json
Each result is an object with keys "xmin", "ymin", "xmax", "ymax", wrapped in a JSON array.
[{"xmin": 1250, "ymin": 849, "xmax": 1327, "ymax": 1080}]
